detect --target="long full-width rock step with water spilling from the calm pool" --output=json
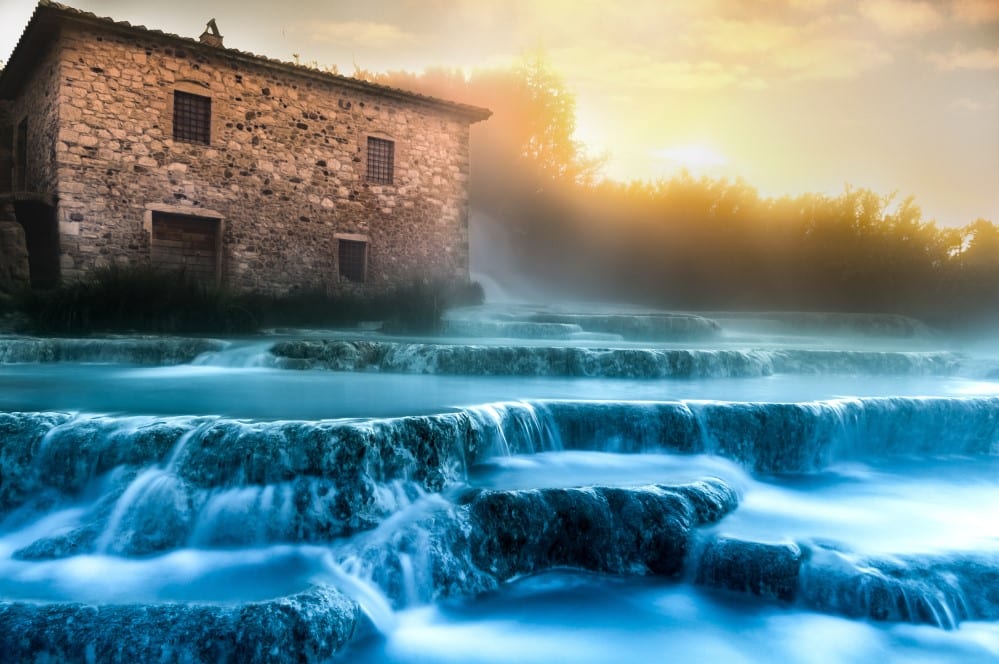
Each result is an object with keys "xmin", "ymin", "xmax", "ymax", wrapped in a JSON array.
[{"xmin": 0, "ymin": 397, "xmax": 999, "ymax": 528}]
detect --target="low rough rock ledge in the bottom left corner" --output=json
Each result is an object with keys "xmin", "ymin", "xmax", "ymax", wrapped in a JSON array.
[{"xmin": 0, "ymin": 586, "xmax": 364, "ymax": 664}]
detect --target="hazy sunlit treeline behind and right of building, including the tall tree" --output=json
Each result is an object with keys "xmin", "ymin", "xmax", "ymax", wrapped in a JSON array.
[{"xmin": 357, "ymin": 57, "xmax": 999, "ymax": 326}]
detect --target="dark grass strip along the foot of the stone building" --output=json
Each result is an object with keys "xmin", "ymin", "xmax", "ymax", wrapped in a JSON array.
[{"xmin": 16, "ymin": 266, "xmax": 482, "ymax": 335}]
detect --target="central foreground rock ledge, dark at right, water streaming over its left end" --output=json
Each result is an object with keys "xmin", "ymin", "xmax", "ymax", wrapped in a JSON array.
[{"xmin": 337, "ymin": 478, "xmax": 738, "ymax": 607}]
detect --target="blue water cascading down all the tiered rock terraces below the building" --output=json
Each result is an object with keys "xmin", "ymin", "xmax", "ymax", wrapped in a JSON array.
[{"xmin": 0, "ymin": 316, "xmax": 999, "ymax": 662}]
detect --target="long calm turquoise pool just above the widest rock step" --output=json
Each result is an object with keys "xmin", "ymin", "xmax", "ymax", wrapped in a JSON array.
[{"xmin": 0, "ymin": 364, "xmax": 999, "ymax": 419}]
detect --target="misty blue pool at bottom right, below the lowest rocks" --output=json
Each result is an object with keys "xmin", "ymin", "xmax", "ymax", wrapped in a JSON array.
[{"xmin": 346, "ymin": 571, "xmax": 999, "ymax": 664}]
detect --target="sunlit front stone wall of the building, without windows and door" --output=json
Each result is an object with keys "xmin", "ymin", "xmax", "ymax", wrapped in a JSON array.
[{"xmin": 49, "ymin": 25, "xmax": 469, "ymax": 292}]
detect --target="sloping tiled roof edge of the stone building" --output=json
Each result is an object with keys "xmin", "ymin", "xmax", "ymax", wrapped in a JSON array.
[{"xmin": 0, "ymin": 0, "xmax": 492, "ymax": 122}]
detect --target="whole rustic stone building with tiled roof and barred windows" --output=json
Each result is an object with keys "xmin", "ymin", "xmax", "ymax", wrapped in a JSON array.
[{"xmin": 0, "ymin": 0, "xmax": 490, "ymax": 293}]
